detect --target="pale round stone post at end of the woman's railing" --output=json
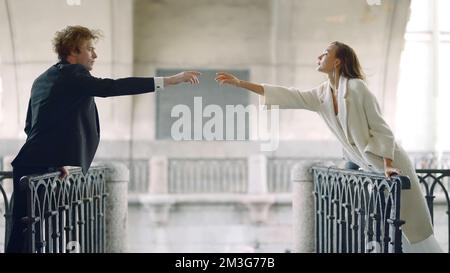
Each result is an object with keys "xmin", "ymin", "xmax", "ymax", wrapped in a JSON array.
[{"xmin": 291, "ymin": 162, "xmax": 318, "ymax": 253}]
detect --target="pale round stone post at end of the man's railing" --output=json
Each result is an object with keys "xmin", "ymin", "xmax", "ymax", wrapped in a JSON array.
[{"xmin": 103, "ymin": 162, "xmax": 130, "ymax": 253}]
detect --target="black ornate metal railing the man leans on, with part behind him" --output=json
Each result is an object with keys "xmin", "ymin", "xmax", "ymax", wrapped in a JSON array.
[{"xmin": 0, "ymin": 167, "xmax": 107, "ymax": 253}]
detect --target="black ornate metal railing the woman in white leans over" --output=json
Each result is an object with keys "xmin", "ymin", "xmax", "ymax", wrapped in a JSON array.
[{"xmin": 312, "ymin": 167, "xmax": 410, "ymax": 253}]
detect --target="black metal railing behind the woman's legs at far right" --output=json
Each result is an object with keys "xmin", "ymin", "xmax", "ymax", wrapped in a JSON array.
[{"xmin": 416, "ymin": 169, "xmax": 450, "ymax": 253}]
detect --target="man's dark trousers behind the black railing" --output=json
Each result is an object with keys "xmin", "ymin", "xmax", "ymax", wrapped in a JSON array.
[{"xmin": 5, "ymin": 166, "xmax": 49, "ymax": 253}]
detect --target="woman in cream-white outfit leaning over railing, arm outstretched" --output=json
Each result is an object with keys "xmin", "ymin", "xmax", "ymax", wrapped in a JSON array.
[{"xmin": 216, "ymin": 42, "xmax": 442, "ymax": 252}]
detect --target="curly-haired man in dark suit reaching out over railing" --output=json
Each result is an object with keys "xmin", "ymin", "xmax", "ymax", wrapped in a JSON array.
[{"xmin": 6, "ymin": 26, "xmax": 200, "ymax": 252}]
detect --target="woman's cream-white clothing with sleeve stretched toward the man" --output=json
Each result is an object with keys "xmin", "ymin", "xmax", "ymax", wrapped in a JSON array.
[{"xmin": 261, "ymin": 76, "xmax": 433, "ymax": 243}]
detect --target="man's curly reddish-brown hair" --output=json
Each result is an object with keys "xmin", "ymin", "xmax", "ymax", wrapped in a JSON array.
[{"xmin": 53, "ymin": 26, "xmax": 102, "ymax": 60}]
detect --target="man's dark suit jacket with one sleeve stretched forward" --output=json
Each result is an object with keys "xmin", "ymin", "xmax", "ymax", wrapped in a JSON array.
[{"xmin": 12, "ymin": 62, "xmax": 155, "ymax": 173}]
